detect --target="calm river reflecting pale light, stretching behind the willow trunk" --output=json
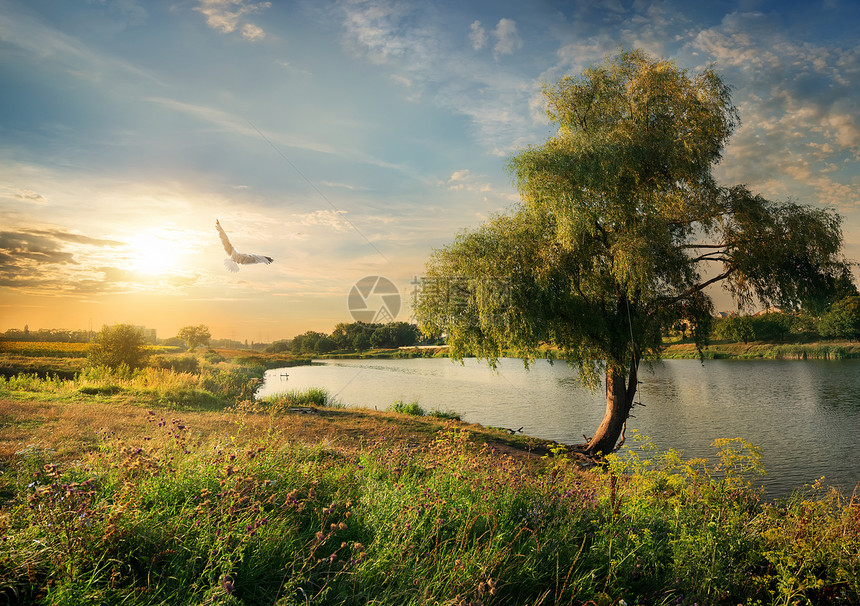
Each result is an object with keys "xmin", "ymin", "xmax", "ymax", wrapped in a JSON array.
[{"xmin": 257, "ymin": 358, "xmax": 860, "ymax": 498}]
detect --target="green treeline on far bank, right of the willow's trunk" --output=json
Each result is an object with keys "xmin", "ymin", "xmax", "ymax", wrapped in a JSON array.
[{"xmin": 713, "ymin": 296, "xmax": 860, "ymax": 343}]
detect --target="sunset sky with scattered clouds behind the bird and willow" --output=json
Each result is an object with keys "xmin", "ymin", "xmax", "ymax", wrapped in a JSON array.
[{"xmin": 0, "ymin": 0, "xmax": 860, "ymax": 342}]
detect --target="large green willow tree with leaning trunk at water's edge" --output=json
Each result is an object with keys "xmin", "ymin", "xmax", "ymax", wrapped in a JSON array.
[{"xmin": 414, "ymin": 51, "xmax": 847, "ymax": 454}]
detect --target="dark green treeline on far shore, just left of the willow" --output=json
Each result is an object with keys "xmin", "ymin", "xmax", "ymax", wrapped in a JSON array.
[{"xmin": 266, "ymin": 322, "xmax": 421, "ymax": 354}]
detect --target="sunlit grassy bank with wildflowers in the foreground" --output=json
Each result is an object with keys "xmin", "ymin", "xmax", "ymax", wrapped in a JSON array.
[{"xmin": 0, "ymin": 371, "xmax": 860, "ymax": 606}]
